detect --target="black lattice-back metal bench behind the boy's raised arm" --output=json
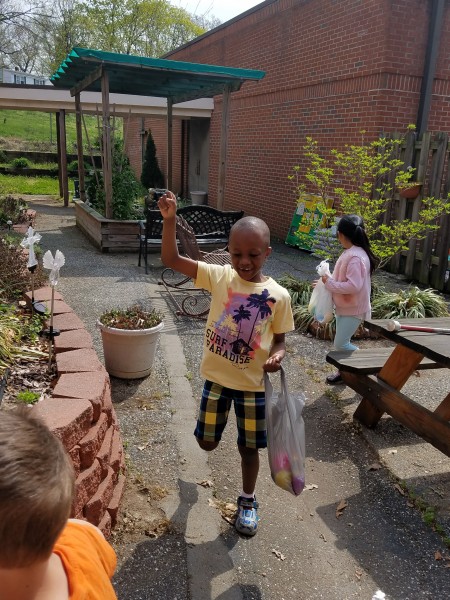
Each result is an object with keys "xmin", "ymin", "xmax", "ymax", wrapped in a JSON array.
[{"xmin": 138, "ymin": 204, "xmax": 244, "ymax": 273}]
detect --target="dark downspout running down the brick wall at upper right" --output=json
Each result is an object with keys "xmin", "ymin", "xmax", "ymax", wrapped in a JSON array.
[{"xmin": 416, "ymin": 0, "xmax": 445, "ymax": 137}]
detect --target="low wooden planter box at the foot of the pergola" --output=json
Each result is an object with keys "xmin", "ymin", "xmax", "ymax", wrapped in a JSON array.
[{"xmin": 74, "ymin": 200, "xmax": 139, "ymax": 252}]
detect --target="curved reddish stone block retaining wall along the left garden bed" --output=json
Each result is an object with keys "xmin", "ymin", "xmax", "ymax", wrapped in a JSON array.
[{"xmin": 26, "ymin": 287, "xmax": 125, "ymax": 536}]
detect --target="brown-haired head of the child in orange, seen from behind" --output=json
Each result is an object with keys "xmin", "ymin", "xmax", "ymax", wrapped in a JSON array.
[{"xmin": 0, "ymin": 408, "xmax": 74, "ymax": 569}]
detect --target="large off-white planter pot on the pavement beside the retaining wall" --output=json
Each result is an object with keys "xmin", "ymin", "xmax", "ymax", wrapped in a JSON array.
[{"xmin": 97, "ymin": 321, "xmax": 164, "ymax": 379}]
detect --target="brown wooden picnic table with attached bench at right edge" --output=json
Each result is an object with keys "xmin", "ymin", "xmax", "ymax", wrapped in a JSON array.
[{"xmin": 327, "ymin": 317, "xmax": 450, "ymax": 456}]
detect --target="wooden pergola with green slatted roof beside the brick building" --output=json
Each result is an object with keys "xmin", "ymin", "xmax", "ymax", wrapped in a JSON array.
[{"xmin": 50, "ymin": 48, "xmax": 265, "ymax": 218}]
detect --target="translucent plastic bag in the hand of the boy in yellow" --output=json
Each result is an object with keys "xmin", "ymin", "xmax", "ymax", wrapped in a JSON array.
[{"xmin": 264, "ymin": 369, "xmax": 305, "ymax": 496}]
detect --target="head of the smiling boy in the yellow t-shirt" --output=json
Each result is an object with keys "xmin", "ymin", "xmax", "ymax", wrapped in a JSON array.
[{"xmin": 228, "ymin": 217, "xmax": 272, "ymax": 283}]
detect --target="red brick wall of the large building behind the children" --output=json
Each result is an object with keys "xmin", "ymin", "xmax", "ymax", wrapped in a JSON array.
[{"xmin": 124, "ymin": 0, "xmax": 450, "ymax": 238}]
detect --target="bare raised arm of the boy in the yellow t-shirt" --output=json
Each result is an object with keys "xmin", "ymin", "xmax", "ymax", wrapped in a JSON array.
[{"xmin": 158, "ymin": 192, "xmax": 197, "ymax": 279}]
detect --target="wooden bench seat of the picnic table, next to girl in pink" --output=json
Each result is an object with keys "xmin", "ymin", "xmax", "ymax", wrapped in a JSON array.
[{"xmin": 326, "ymin": 347, "xmax": 442, "ymax": 375}]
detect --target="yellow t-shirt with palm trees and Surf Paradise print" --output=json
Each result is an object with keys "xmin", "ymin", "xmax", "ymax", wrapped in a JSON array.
[{"xmin": 195, "ymin": 262, "xmax": 294, "ymax": 392}]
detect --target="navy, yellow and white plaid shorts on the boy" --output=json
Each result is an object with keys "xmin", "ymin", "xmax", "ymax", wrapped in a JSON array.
[{"xmin": 194, "ymin": 380, "xmax": 267, "ymax": 448}]
